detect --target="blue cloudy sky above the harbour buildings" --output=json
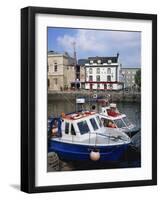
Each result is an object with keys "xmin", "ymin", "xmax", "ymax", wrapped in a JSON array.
[{"xmin": 48, "ymin": 27, "xmax": 141, "ymax": 67}]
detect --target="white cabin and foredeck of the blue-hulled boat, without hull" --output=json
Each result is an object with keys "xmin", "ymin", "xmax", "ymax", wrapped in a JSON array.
[{"xmin": 51, "ymin": 111, "xmax": 130, "ymax": 145}]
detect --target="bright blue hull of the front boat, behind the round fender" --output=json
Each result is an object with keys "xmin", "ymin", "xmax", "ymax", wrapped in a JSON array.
[{"xmin": 48, "ymin": 140, "xmax": 129, "ymax": 161}]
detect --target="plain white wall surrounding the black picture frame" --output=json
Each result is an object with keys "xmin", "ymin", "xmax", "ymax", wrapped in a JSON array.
[{"xmin": 0, "ymin": 0, "xmax": 161, "ymax": 200}]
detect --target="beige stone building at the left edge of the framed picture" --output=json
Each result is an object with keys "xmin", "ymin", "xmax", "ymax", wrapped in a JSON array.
[{"xmin": 48, "ymin": 51, "xmax": 75, "ymax": 91}]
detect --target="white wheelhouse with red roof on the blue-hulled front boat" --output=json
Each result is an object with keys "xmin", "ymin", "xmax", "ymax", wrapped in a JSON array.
[{"xmin": 62, "ymin": 111, "xmax": 104, "ymax": 141}]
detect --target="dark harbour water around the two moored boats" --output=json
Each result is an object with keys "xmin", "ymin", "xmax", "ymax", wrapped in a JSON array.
[{"xmin": 48, "ymin": 97, "xmax": 141, "ymax": 172}]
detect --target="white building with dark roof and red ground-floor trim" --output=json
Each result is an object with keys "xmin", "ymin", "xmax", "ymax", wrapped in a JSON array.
[{"xmin": 85, "ymin": 54, "xmax": 123, "ymax": 90}]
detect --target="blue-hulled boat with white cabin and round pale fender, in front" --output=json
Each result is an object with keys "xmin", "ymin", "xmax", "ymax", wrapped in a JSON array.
[{"xmin": 48, "ymin": 111, "xmax": 131, "ymax": 161}]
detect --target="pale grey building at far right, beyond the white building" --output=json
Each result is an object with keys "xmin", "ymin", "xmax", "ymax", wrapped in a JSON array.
[{"xmin": 121, "ymin": 67, "xmax": 140, "ymax": 89}]
